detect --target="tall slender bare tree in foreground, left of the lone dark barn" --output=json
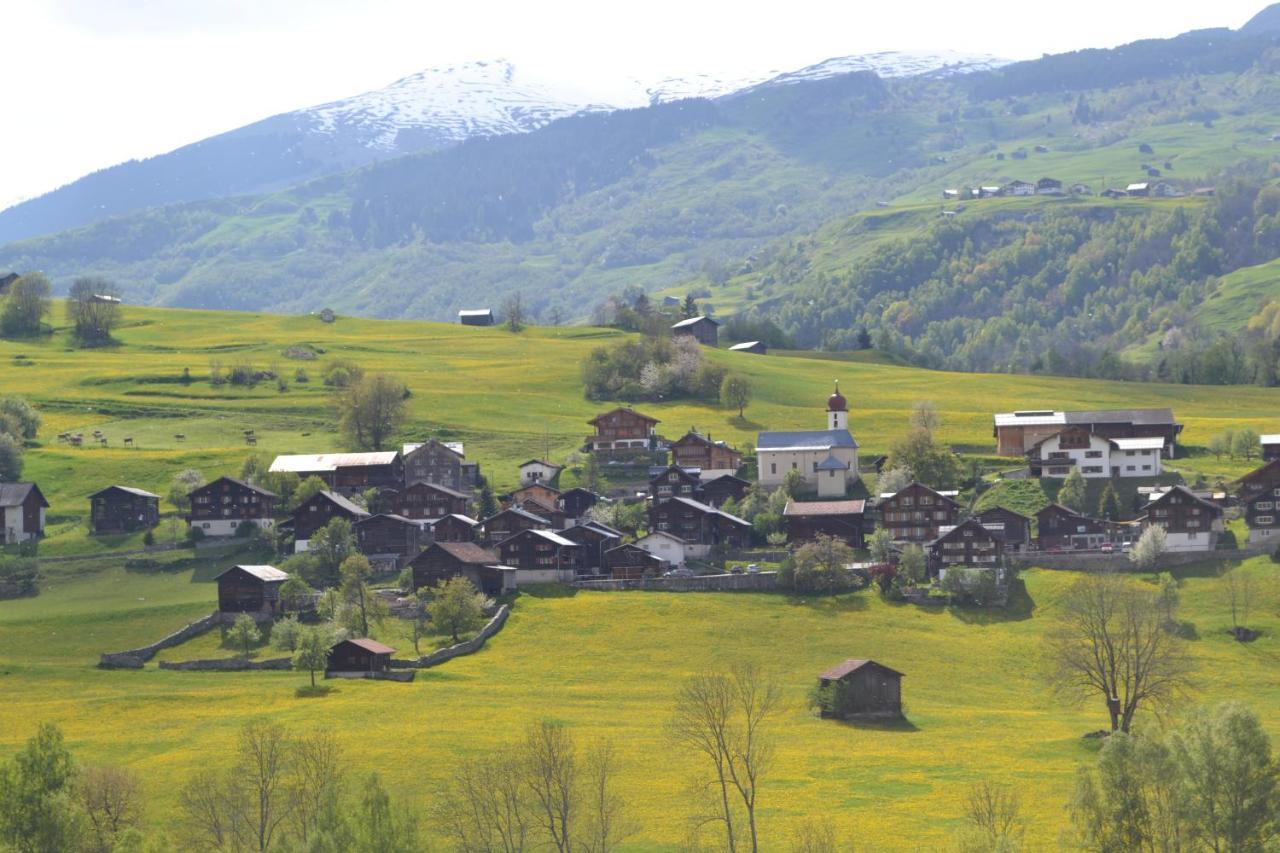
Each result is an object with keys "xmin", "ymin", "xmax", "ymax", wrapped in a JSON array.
[{"xmin": 671, "ymin": 665, "xmax": 782, "ymax": 853}]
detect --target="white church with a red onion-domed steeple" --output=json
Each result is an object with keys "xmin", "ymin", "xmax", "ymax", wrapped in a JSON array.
[{"xmin": 755, "ymin": 382, "xmax": 858, "ymax": 498}]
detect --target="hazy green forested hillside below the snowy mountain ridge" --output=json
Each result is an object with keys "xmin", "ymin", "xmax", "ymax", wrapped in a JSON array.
[{"xmin": 0, "ymin": 20, "xmax": 1280, "ymax": 382}]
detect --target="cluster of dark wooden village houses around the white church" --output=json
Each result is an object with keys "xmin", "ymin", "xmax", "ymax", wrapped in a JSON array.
[{"xmin": 10, "ymin": 387, "xmax": 1280, "ymax": 593}]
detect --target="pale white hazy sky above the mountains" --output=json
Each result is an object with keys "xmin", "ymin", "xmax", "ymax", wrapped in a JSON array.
[{"xmin": 0, "ymin": 0, "xmax": 1266, "ymax": 207}]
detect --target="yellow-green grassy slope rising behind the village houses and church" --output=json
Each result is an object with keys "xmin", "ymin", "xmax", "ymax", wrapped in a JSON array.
[{"xmin": 10, "ymin": 307, "xmax": 1277, "ymax": 545}]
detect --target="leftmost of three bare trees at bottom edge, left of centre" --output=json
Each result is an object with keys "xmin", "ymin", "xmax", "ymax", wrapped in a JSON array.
[{"xmin": 434, "ymin": 757, "xmax": 529, "ymax": 853}]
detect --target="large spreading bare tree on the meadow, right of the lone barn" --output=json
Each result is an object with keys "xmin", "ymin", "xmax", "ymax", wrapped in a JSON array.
[{"xmin": 1046, "ymin": 575, "xmax": 1192, "ymax": 731}]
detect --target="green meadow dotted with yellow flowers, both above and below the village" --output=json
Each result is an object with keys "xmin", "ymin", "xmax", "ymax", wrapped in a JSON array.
[{"xmin": 0, "ymin": 306, "xmax": 1280, "ymax": 850}]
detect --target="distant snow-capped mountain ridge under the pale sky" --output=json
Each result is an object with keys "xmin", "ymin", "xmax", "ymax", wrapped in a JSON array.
[{"xmin": 0, "ymin": 51, "xmax": 1002, "ymax": 245}]
